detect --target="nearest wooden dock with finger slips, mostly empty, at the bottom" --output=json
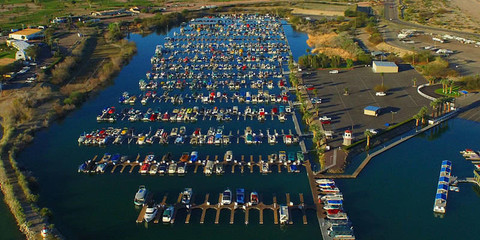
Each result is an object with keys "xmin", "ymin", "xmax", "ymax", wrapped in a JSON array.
[{"xmin": 136, "ymin": 193, "xmax": 317, "ymax": 224}]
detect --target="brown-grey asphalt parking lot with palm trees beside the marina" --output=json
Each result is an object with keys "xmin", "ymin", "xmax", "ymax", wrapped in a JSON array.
[{"xmin": 303, "ymin": 66, "xmax": 429, "ymax": 147}]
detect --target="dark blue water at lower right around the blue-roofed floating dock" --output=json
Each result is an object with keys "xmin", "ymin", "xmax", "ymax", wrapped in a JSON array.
[{"xmin": 338, "ymin": 119, "xmax": 480, "ymax": 239}]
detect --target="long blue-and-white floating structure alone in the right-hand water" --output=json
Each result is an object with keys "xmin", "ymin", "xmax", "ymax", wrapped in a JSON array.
[{"xmin": 433, "ymin": 160, "xmax": 452, "ymax": 213}]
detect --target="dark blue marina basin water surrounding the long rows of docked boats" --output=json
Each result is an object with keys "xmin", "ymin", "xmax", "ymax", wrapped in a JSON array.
[{"xmin": 14, "ymin": 17, "xmax": 320, "ymax": 239}]
